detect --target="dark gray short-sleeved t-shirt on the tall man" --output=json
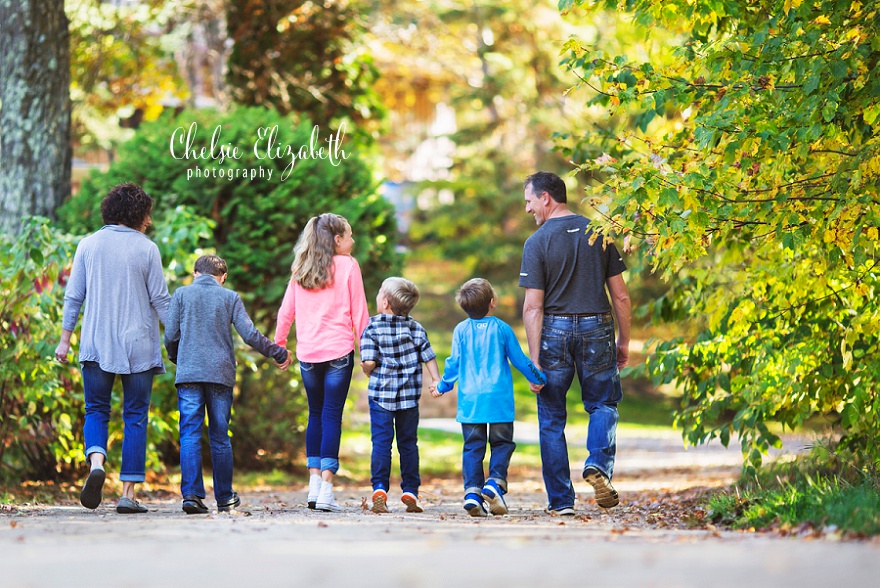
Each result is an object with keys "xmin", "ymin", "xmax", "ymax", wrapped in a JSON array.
[{"xmin": 519, "ymin": 214, "xmax": 626, "ymax": 314}]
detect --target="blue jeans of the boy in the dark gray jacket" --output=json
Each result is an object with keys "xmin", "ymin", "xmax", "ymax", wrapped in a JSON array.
[{"xmin": 177, "ymin": 383, "xmax": 232, "ymax": 503}]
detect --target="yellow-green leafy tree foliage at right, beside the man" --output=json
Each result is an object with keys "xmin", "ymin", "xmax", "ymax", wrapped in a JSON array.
[{"xmin": 560, "ymin": 0, "xmax": 880, "ymax": 465}]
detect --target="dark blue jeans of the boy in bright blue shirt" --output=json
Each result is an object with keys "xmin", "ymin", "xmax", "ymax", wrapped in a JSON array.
[{"xmin": 461, "ymin": 423, "xmax": 516, "ymax": 496}]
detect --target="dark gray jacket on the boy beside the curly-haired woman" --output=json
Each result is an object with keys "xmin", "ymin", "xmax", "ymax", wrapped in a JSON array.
[{"xmin": 165, "ymin": 275, "xmax": 287, "ymax": 388}]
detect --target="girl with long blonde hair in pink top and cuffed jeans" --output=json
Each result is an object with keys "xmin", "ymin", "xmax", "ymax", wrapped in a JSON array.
[{"xmin": 275, "ymin": 214, "xmax": 370, "ymax": 512}]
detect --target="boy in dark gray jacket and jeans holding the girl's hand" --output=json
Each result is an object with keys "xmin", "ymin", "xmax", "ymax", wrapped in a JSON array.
[{"xmin": 165, "ymin": 255, "xmax": 290, "ymax": 514}]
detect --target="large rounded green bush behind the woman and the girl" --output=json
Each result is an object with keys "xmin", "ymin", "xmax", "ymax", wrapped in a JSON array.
[{"xmin": 58, "ymin": 107, "xmax": 400, "ymax": 468}]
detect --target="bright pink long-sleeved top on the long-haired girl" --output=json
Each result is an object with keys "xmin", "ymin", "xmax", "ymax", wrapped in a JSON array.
[{"xmin": 275, "ymin": 255, "xmax": 370, "ymax": 363}]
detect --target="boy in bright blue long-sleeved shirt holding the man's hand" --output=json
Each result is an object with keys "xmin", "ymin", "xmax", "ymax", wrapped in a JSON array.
[{"xmin": 431, "ymin": 278, "xmax": 547, "ymax": 517}]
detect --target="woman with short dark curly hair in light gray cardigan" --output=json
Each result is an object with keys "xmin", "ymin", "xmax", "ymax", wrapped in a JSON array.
[{"xmin": 55, "ymin": 184, "xmax": 171, "ymax": 514}]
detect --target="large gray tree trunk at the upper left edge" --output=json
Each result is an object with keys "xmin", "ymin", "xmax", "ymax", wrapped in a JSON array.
[{"xmin": 0, "ymin": 0, "xmax": 71, "ymax": 233}]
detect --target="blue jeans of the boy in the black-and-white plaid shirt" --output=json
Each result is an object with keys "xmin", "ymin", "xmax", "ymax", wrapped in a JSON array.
[{"xmin": 370, "ymin": 398, "xmax": 422, "ymax": 496}]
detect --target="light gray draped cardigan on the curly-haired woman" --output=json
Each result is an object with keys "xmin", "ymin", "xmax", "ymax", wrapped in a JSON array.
[{"xmin": 61, "ymin": 225, "xmax": 171, "ymax": 374}]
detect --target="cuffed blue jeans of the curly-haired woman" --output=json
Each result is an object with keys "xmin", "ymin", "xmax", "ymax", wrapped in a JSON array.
[{"xmin": 82, "ymin": 361, "xmax": 153, "ymax": 482}]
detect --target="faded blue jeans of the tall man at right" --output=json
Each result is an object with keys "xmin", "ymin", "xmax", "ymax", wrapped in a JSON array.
[{"xmin": 537, "ymin": 314, "xmax": 623, "ymax": 510}]
